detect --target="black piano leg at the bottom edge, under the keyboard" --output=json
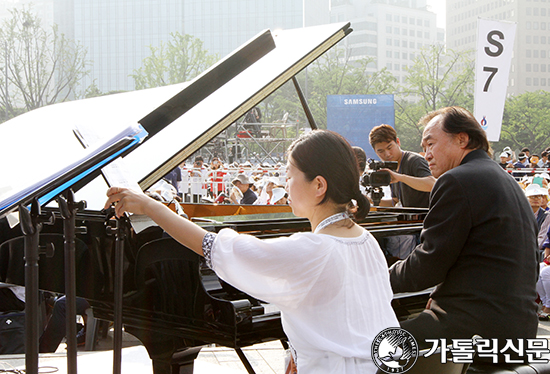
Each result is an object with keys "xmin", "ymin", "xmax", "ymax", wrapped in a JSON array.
[{"xmin": 125, "ymin": 326, "xmax": 202, "ymax": 374}]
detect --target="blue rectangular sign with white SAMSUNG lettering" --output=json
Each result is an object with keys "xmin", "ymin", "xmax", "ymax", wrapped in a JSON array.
[{"xmin": 327, "ymin": 95, "xmax": 395, "ymax": 159}]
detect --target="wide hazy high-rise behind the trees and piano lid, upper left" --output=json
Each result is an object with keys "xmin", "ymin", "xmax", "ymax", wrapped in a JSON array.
[{"xmin": 54, "ymin": 0, "xmax": 328, "ymax": 92}]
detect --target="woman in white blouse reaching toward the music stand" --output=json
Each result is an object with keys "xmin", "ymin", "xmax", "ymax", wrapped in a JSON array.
[{"xmin": 105, "ymin": 130, "xmax": 399, "ymax": 374}]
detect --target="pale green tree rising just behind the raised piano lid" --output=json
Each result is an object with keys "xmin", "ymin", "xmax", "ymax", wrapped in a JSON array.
[{"xmin": 130, "ymin": 32, "xmax": 219, "ymax": 89}]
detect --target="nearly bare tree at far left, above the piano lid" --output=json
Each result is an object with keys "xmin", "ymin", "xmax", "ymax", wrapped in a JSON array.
[{"xmin": 0, "ymin": 8, "xmax": 88, "ymax": 118}]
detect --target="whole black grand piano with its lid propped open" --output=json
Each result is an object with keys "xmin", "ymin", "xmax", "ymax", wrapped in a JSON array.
[{"xmin": 0, "ymin": 23, "xmax": 427, "ymax": 374}]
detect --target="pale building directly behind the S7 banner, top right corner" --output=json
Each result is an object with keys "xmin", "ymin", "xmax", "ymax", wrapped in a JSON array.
[{"xmin": 447, "ymin": 0, "xmax": 550, "ymax": 95}]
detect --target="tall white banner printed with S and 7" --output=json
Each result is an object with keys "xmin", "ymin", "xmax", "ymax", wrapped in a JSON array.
[{"xmin": 474, "ymin": 18, "xmax": 517, "ymax": 142}]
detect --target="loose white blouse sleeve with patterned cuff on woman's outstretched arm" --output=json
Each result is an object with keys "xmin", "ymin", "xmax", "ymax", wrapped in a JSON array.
[{"xmin": 207, "ymin": 229, "xmax": 330, "ymax": 307}]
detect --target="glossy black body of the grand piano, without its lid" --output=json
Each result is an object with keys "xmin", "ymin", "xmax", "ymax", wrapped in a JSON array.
[{"xmin": 0, "ymin": 209, "xmax": 428, "ymax": 374}]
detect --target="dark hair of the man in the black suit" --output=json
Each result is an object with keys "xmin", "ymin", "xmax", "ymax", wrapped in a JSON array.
[{"xmin": 420, "ymin": 106, "xmax": 493, "ymax": 156}]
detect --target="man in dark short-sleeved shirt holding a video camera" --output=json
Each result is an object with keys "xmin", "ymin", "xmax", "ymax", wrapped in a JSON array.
[{"xmin": 369, "ymin": 125, "xmax": 435, "ymax": 208}]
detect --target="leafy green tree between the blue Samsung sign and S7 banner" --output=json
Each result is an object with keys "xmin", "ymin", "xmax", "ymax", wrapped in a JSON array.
[{"xmin": 395, "ymin": 45, "xmax": 474, "ymax": 150}]
